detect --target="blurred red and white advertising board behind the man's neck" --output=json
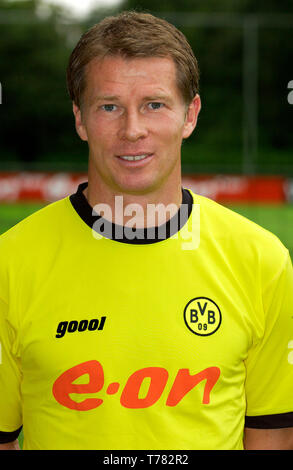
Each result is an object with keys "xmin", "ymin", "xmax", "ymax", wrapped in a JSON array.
[{"xmin": 0, "ymin": 172, "xmax": 292, "ymax": 203}]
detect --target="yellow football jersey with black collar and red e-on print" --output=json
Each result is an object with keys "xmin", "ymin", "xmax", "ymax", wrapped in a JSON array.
[{"xmin": 0, "ymin": 183, "xmax": 293, "ymax": 450}]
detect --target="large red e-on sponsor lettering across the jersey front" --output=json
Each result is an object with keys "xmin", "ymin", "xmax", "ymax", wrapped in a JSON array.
[{"xmin": 52, "ymin": 360, "xmax": 220, "ymax": 411}]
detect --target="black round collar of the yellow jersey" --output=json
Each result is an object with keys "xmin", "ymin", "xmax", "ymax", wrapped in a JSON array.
[{"xmin": 69, "ymin": 182, "xmax": 193, "ymax": 245}]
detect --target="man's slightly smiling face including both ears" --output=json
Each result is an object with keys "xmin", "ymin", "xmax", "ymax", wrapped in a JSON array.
[{"xmin": 73, "ymin": 56, "xmax": 200, "ymax": 194}]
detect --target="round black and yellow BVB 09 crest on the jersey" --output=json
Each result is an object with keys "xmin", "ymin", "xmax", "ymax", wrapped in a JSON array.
[{"xmin": 184, "ymin": 297, "xmax": 222, "ymax": 336}]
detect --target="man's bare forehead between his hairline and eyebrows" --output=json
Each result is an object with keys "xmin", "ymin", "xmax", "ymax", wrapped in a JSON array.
[{"xmin": 86, "ymin": 56, "xmax": 180, "ymax": 99}]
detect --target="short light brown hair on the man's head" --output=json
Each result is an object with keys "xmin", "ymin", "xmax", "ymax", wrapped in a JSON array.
[{"xmin": 67, "ymin": 11, "xmax": 199, "ymax": 108}]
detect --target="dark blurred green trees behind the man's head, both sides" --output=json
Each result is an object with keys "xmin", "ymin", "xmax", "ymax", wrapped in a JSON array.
[{"xmin": 0, "ymin": 0, "xmax": 293, "ymax": 174}]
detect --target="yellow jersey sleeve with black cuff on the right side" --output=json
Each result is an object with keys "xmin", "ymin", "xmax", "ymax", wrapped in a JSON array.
[{"xmin": 246, "ymin": 250, "xmax": 293, "ymax": 428}]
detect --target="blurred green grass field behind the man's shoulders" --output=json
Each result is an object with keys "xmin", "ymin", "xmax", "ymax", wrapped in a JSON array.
[{"xmin": 0, "ymin": 204, "xmax": 293, "ymax": 448}]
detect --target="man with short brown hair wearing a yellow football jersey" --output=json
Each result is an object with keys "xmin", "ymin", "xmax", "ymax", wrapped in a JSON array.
[{"xmin": 0, "ymin": 12, "xmax": 293, "ymax": 449}]
